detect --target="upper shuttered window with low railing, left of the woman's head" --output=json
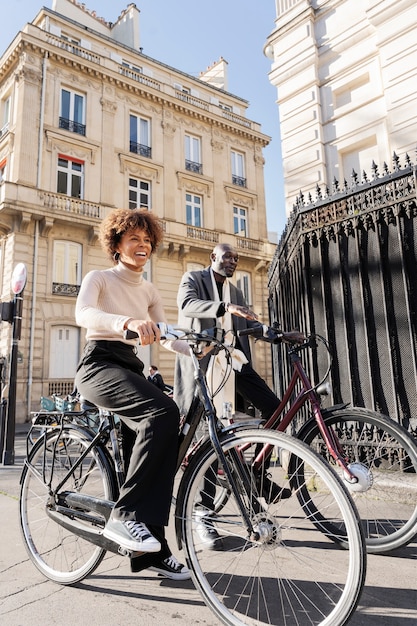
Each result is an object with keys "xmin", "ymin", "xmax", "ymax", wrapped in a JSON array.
[{"xmin": 52, "ymin": 241, "xmax": 82, "ymax": 296}]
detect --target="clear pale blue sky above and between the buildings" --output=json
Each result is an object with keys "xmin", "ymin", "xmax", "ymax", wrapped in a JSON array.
[{"xmin": 0, "ymin": 0, "xmax": 286, "ymax": 233}]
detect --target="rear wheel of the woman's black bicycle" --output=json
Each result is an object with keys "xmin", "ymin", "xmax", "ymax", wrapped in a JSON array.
[{"xmin": 19, "ymin": 427, "xmax": 116, "ymax": 585}]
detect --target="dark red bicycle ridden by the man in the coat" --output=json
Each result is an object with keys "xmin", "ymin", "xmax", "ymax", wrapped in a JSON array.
[{"xmin": 236, "ymin": 324, "xmax": 417, "ymax": 553}]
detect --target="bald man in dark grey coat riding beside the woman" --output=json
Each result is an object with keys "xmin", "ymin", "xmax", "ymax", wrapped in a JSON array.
[{"xmin": 174, "ymin": 243, "xmax": 290, "ymax": 549}]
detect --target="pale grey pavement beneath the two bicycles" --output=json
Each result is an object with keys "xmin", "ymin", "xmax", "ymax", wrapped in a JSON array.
[{"xmin": 0, "ymin": 425, "xmax": 417, "ymax": 626}]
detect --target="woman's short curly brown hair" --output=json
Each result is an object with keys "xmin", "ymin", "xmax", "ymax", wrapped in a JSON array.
[{"xmin": 99, "ymin": 209, "xmax": 163, "ymax": 262}]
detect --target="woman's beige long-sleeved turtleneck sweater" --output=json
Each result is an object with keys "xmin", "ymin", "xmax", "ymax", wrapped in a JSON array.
[{"xmin": 75, "ymin": 262, "xmax": 189, "ymax": 354}]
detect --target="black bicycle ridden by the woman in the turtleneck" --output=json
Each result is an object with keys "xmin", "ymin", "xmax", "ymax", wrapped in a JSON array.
[{"xmin": 20, "ymin": 330, "xmax": 366, "ymax": 626}]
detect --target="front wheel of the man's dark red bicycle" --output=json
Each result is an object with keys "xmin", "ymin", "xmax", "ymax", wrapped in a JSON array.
[{"xmin": 297, "ymin": 407, "xmax": 417, "ymax": 554}]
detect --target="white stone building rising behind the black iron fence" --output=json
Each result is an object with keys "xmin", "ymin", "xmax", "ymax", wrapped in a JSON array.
[{"xmin": 264, "ymin": 0, "xmax": 417, "ymax": 215}]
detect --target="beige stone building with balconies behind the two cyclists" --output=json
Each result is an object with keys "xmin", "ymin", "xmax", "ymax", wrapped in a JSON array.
[{"xmin": 0, "ymin": 0, "xmax": 274, "ymax": 422}]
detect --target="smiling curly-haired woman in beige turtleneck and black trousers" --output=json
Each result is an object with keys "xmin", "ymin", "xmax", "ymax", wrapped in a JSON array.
[{"xmin": 76, "ymin": 209, "xmax": 190, "ymax": 580}]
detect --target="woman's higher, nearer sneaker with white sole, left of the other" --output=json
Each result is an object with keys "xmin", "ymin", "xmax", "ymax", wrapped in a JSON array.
[{"xmin": 103, "ymin": 517, "xmax": 161, "ymax": 552}]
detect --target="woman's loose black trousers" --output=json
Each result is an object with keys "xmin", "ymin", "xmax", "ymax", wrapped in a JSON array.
[{"xmin": 75, "ymin": 341, "xmax": 179, "ymax": 528}]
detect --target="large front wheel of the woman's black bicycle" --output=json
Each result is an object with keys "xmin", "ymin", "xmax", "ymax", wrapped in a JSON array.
[{"xmin": 176, "ymin": 429, "xmax": 366, "ymax": 626}]
